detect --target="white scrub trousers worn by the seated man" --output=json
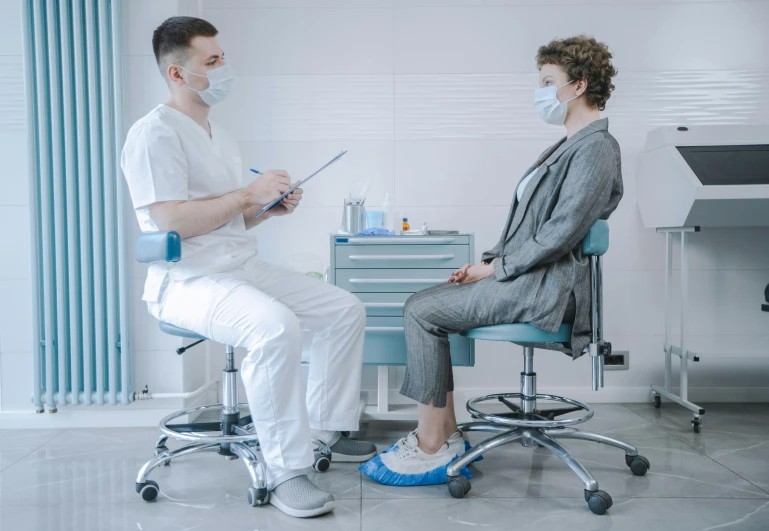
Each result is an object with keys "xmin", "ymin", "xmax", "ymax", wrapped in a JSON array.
[{"xmin": 148, "ymin": 258, "xmax": 366, "ymax": 469}]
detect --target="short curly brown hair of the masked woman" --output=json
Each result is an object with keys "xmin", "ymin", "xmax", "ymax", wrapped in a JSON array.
[{"xmin": 537, "ymin": 35, "xmax": 617, "ymax": 111}]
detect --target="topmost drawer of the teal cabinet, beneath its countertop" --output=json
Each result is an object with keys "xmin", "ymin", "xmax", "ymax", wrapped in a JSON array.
[{"xmin": 336, "ymin": 245, "xmax": 470, "ymax": 269}]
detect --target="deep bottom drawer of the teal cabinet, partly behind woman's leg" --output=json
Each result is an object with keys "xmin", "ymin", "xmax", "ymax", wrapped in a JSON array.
[{"xmin": 363, "ymin": 317, "xmax": 475, "ymax": 366}]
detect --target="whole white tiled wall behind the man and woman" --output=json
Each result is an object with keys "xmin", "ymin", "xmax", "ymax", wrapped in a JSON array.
[{"xmin": 0, "ymin": 0, "xmax": 769, "ymax": 410}]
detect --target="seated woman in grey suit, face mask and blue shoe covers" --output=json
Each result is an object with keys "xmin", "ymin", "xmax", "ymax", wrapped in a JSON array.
[{"xmin": 361, "ymin": 35, "xmax": 622, "ymax": 485}]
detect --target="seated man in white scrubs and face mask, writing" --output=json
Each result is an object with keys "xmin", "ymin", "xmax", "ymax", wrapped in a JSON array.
[{"xmin": 121, "ymin": 17, "xmax": 376, "ymax": 517}]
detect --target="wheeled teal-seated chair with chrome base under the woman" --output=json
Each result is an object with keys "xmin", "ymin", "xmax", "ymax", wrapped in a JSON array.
[{"xmin": 446, "ymin": 220, "xmax": 649, "ymax": 514}]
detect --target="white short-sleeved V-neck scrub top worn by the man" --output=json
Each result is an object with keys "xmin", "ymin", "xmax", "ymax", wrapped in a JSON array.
[{"xmin": 121, "ymin": 105, "xmax": 257, "ymax": 302}]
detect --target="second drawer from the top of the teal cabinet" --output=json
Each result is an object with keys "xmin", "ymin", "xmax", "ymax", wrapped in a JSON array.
[{"xmin": 336, "ymin": 269, "xmax": 454, "ymax": 293}]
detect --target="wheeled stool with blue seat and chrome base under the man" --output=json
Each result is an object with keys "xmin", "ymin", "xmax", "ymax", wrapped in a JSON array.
[{"xmin": 135, "ymin": 232, "xmax": 331, "ymax": 507}]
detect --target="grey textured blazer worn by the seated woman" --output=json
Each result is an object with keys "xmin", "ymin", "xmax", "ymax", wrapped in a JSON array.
[{"xmin": 475, "ymin": 118, "xmax": 623, "ymax": 358}]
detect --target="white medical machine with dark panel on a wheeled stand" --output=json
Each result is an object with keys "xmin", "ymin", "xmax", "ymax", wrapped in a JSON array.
[{"xmin": 636, "ymin": 124, "xmax": 769, "ymax": 433}]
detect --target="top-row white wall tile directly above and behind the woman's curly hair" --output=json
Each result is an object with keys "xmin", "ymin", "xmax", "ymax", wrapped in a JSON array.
[{"xmin": 394, "ymin": 0, "xmax": 769, "ymax": 74}]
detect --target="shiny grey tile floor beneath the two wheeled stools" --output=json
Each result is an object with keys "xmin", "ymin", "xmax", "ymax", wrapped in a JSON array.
[{"xmin": 0, "ymin": 404, "xmax": 769, "ymax": 531}]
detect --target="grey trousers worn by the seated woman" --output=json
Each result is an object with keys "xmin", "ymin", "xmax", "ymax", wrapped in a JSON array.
[{"xmin": 400, "ymin": 283, "xmax": 576, "ymax": 407}]
